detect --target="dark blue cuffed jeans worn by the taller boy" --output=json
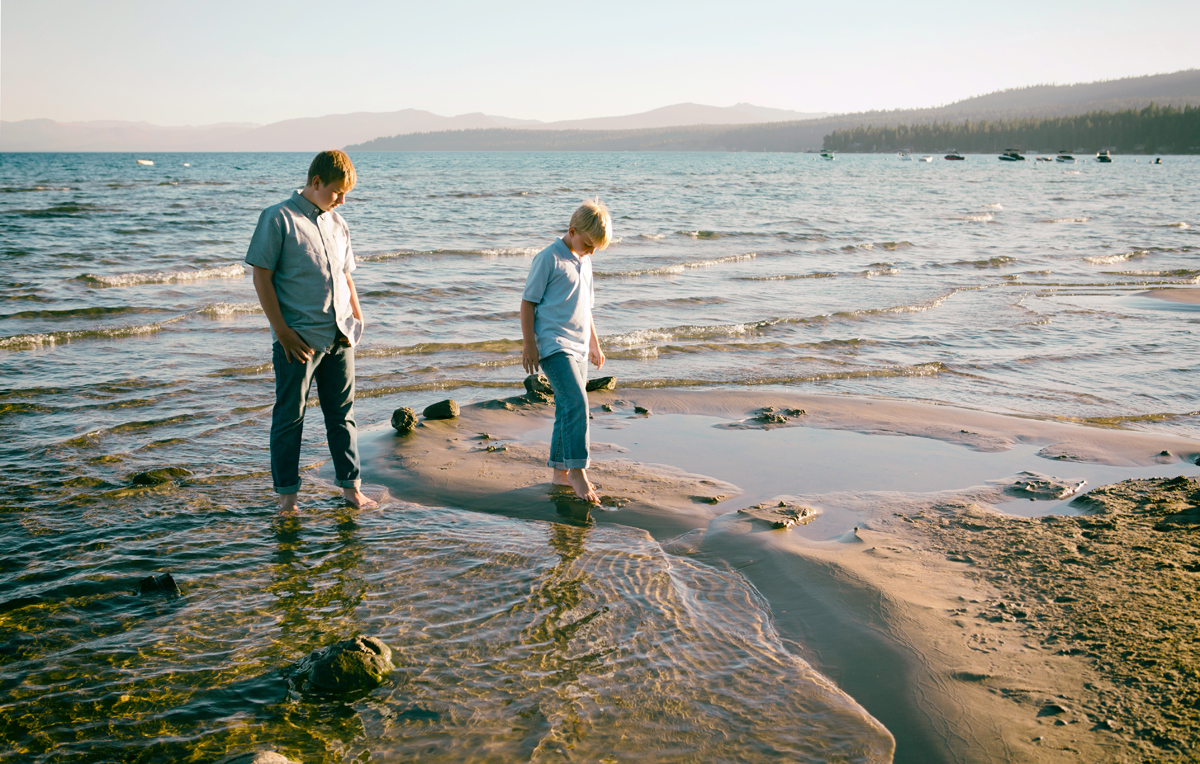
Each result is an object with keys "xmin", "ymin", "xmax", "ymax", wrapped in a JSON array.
[{"xmin": 271, "ymin": 342, "xmax": 362, "ymax": 494}]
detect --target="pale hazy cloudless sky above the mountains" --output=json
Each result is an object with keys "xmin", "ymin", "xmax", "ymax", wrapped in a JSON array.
[{"xmin": 0, "ymin": 0, "xmax": 1200, "ymax": 125}]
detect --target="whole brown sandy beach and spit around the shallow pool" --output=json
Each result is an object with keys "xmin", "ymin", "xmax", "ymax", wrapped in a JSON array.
[{"xmin": 362, "ymin": 389, "xmax": 1200, "ymax": 763}]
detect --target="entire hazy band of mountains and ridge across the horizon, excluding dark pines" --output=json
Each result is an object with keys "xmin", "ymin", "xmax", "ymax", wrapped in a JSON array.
[{"xmin": 0, "ymin": 70, "xmax": 1200, "ymax": 152}]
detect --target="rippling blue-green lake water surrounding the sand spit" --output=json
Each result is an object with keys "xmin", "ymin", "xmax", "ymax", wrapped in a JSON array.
[{"xmin": 0, "ymin": 154, "xmax": 1200, "ymax": 762}]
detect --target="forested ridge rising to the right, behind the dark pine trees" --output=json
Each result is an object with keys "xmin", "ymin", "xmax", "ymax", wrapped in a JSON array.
[{"xmin": 346, "ymin": 70, "xmax": 1200, "ymax": 151}]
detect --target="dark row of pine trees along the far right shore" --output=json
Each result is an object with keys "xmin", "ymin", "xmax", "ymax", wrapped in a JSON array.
[{"xmin": 824, "ymin": 103, "xmax": 1200, "ymax": 154}]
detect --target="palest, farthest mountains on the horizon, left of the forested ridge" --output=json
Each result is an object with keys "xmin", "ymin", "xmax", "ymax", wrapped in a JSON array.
[{"xmin": 0, "ymin": 103, "xmax": 824, "ymax": 151}]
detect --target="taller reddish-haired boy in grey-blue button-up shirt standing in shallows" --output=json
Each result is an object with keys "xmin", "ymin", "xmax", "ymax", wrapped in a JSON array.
[{"xmin": 246, "ymin": 150, "xmax": 376, "ymax": 512}]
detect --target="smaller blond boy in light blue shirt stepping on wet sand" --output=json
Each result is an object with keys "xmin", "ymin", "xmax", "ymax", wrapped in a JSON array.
[{"xmin": 521, "ymin": 199, "xmax": 612, "ymax": 504}]
